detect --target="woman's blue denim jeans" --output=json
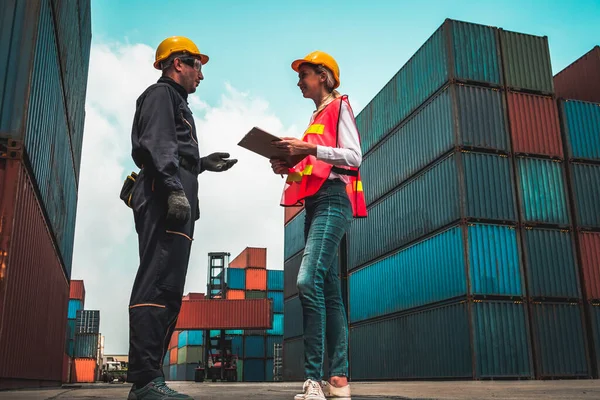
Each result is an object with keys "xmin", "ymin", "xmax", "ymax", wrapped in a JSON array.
[{"xmin": 297, "ymin": 180, "xmax": 352, "ymax": 381}]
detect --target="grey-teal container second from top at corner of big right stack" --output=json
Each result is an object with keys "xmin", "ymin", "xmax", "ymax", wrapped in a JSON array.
[{"xmin": 361, "ymin": 84, "xmax": 510, "ymax": 204}]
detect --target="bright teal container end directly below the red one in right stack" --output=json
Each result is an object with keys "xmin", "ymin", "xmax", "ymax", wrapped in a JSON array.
[{"xmin": 517, "ymin": 157, "xmax": 569, "ymax": 225}]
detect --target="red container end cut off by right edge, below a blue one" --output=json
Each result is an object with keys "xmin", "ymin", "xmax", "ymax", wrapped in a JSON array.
[{"xmin": 579, "ymin": 232, "xmax": 600, "ymax": 300}]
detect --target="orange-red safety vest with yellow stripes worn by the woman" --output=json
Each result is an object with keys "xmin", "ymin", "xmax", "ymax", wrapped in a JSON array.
[{"xmin": 281, "ymin": 95, "xmax": 367, "ymax": 218}]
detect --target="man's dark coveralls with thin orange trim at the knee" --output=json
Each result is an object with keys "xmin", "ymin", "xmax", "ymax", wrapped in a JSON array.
[{"xmin": 127, "ymin": 77, "xmax": 201, "ymax": 384}]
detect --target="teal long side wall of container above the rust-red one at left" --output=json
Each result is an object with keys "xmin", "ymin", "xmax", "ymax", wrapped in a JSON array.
[{"xmin": 25, "ymin": 0, "xmax": 79, "ymax": 278}]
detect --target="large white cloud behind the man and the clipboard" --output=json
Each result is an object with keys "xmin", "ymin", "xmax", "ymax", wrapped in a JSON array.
[{"xmin": 73, "ymin": 44, "xmax": 298, "ymax": 353}]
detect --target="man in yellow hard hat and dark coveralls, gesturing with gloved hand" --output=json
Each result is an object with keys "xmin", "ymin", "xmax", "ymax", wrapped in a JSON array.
[{"xmin": 127, "ymin": 36, "xmax": 237, "ymax": 400}]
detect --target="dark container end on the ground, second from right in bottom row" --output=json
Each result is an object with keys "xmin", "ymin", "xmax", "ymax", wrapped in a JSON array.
[{"xmin": 531, "ymin": 303, "xmax": 589, "ymax": 378}]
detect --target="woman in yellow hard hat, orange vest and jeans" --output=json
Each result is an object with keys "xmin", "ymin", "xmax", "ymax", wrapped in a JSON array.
[{"xmin": 271, "ymin": 51, "xmax": 367, "ymax": 400}]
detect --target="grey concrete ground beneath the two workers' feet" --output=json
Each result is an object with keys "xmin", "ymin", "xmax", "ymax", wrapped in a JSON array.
[{"xmin": 0, "ymin": 380, "xmax": 600, "ymax": 400}]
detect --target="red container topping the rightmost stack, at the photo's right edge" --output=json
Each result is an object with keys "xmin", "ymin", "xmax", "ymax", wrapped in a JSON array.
[{"xmin": 554, "ymin": 46, "xmax": 600, "ymax": 103}]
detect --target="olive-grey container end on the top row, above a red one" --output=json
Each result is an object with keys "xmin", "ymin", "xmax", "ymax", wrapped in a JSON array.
[{"xmin": 500, "ymin": 29, "xmax": 554, "ymax": 94}]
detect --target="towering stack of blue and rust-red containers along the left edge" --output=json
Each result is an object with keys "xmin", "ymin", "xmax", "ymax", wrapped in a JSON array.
[{"xmin": 0, "ymin": 0, "xmax": 91, "ymax": 388}]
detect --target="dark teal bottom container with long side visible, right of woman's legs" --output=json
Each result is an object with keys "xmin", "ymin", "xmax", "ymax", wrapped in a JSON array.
[{"xmin": 349, "ymin": 300, "xmax": 533, "ymax": 380}]
